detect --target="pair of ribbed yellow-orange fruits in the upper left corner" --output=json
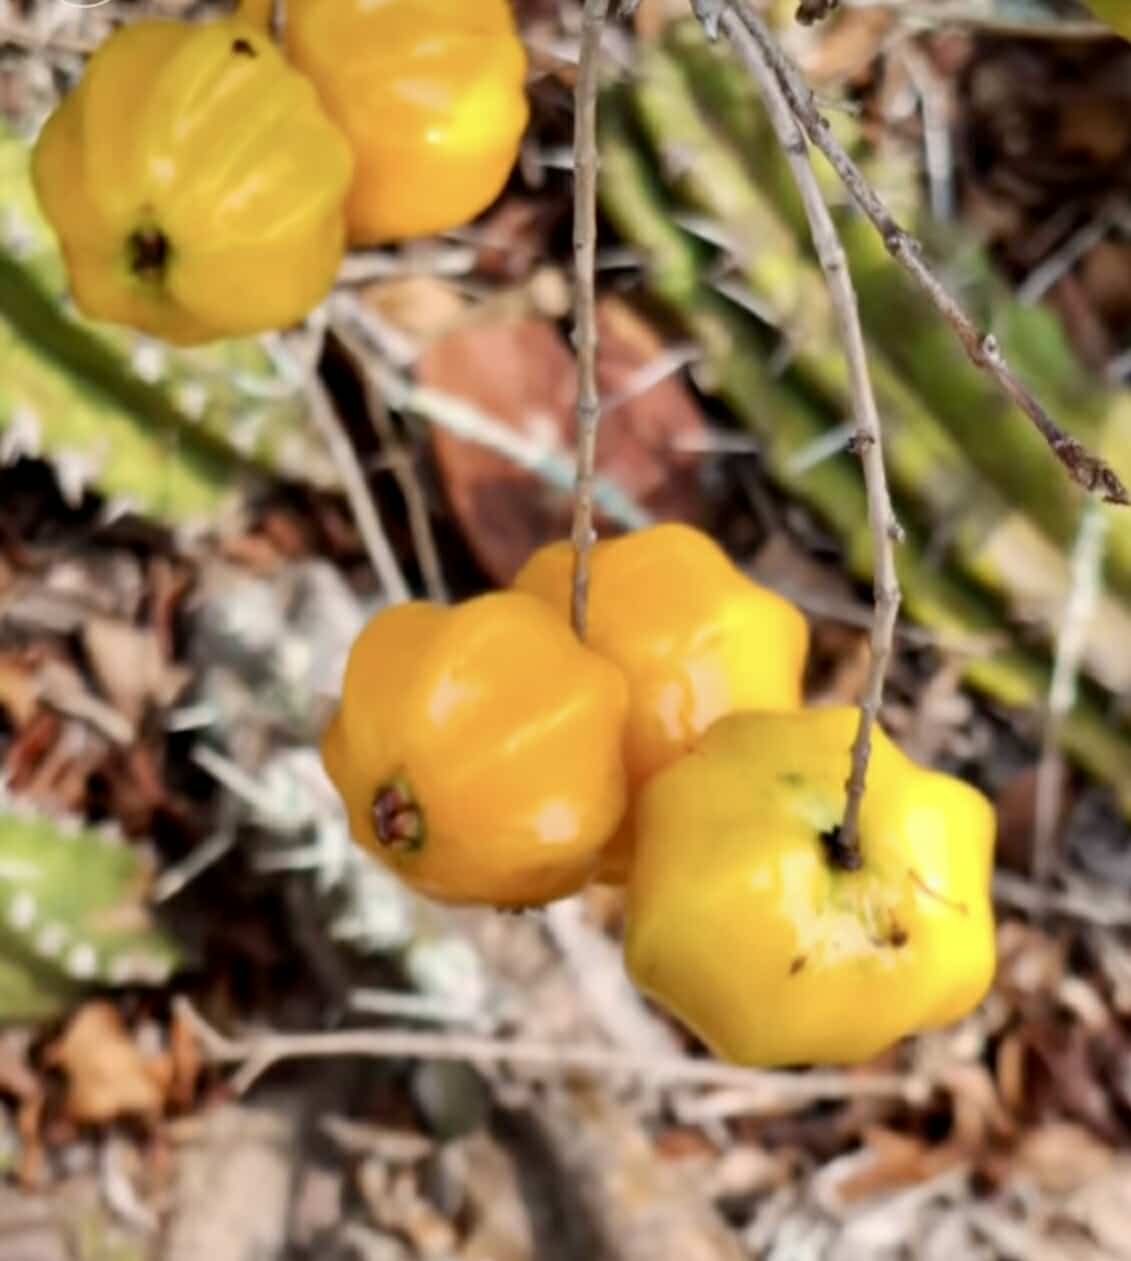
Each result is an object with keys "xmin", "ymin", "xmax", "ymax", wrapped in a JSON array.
[{"xmin": 34, "ymin": 0, "xmax": 528, "ymax": 344}]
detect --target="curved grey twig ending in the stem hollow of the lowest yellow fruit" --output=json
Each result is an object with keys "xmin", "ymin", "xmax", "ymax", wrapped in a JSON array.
[{"xmin": 722, "ymin": 13, "xmax": 900, "ymax": 868}]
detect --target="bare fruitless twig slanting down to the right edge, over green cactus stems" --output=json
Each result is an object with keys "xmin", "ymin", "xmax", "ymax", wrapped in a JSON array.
[{"xmin": 692, "ymin": 0, "xmax": 1131, "ymax": 504}]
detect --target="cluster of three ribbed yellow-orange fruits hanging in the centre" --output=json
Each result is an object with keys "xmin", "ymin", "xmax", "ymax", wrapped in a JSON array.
[{"xmin": 323, "ymin": 525, "xmax": 995, "ymax": 1066}]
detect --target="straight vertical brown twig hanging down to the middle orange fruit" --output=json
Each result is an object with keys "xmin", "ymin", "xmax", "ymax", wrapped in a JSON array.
[{"xmin": 571, "ymin": 0, "xmax": 609, "ymax": 638}]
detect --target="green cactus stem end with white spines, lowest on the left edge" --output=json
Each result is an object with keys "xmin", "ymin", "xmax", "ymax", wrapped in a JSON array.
[{"xmin": 0, "ymin": 787, "xmax": 179, "ymax": 1023}]
